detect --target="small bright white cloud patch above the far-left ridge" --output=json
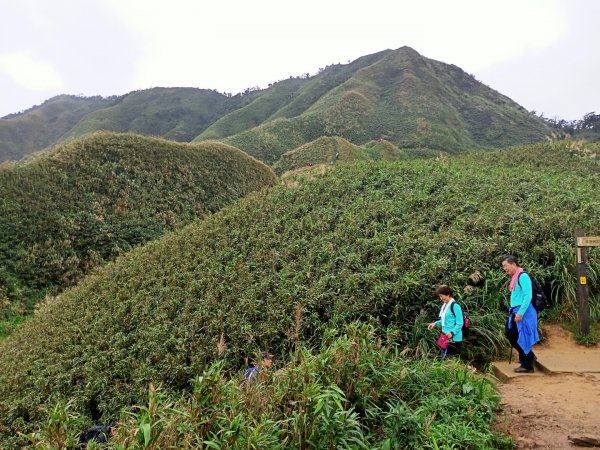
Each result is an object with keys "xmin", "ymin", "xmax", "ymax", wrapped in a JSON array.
[{"xmin": 0, "ymin": 51, "xmax": 64, "ymax": 91}]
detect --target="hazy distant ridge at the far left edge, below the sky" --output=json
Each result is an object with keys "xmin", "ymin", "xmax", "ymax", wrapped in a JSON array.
[{"xmin": 0, "ymin": 95, "xmax": 115, "ymax": 163}]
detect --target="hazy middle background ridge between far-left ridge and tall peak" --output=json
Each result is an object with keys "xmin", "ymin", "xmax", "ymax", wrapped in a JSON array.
[{"xmin": 62, "ymin": 88, "xmax": 255, "ymax": 142}]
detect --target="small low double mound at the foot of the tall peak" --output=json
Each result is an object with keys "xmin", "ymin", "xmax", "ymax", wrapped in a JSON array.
[{"xmin": 273, "ymin": 137, "xmax": 404, "ymax": 175}]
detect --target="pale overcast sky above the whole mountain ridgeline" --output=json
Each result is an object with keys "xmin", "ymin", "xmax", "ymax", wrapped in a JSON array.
[{"xmin": 0, "ymin": 0, "xmax": 600, "ymax": 120}]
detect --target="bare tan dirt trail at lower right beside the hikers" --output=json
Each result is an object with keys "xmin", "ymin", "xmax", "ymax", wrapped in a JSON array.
[{"xmin": 497, "ymin": 326, "xmax": 600, "ymax": 449}]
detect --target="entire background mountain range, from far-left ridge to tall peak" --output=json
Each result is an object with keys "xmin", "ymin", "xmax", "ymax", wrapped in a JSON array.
[{"xmin": 0, "ymin": 47, "xmax": 551, "ymax": 164}]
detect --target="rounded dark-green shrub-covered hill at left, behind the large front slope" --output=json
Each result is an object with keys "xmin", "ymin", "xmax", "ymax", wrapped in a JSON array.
[{"xmin": 0, "ymin": 132, "xmax": 276, "ymax": 299}]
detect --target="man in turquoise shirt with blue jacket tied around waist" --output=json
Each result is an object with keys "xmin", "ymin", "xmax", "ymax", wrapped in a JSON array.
[{"xmin": 502, "ymin": 255, "xmax": 540, "ymax": 373}]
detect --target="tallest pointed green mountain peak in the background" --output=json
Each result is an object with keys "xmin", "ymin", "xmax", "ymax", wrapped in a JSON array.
[{"xmin": 197, "ymin": 47, "xmax": 550, "ymax": 164}]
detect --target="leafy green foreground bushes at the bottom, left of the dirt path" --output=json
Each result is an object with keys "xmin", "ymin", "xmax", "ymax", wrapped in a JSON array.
[{"xmin": 28, "ymin": 324, "xmax": 512, "ymax": 449}]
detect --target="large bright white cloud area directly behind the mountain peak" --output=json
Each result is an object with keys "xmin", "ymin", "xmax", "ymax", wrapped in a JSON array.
[{"xmin": 106, "ymin": 0, "xmax": 565, "ymax": 92}]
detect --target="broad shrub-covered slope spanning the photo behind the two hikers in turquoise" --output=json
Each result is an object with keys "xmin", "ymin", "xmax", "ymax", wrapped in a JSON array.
[{"xmin": 0, "ymin": 142, "xmax": 600, "ymax": 436}]
